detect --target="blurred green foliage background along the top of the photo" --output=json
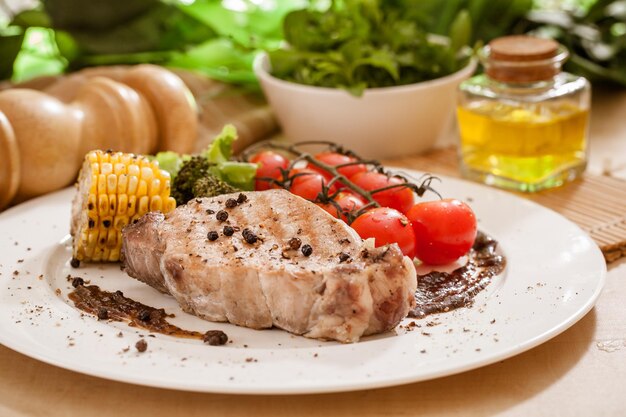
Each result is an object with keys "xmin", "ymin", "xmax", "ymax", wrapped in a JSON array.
[{"xmin": 0, "ymin": 0, "xmax": 626, "ymax": 88}]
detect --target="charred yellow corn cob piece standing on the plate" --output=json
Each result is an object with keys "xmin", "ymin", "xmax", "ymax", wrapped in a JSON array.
[{"xmin": 70, "ymin": 150, "xmax": 176, "ymax": 262}]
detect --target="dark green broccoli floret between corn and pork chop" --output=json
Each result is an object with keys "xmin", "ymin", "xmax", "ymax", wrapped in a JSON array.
[{"xmin": 172, "ymin": 156, "xmax": 238, "ymax": 205}]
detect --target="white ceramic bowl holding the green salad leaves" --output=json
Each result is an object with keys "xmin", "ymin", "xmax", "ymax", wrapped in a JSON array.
[{"xmin": 254, "ymin": 53, "xmax": 476, "ymax": 159}]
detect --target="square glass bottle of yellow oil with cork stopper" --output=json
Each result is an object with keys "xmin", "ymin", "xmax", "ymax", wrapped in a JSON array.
[{"xmin": 457, "ymin": 36, "xmax": 590, "ymax": 192}]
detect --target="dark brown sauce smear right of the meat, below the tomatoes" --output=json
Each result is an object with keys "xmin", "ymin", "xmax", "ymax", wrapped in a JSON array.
[{"xmin": 409, "ymin": 232, "xmax": 506, "ymax": 318}]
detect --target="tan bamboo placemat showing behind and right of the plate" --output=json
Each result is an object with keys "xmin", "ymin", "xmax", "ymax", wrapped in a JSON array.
[{"xmin": 386, "ymin": 148, "xmax": 626, "ymax": 263}]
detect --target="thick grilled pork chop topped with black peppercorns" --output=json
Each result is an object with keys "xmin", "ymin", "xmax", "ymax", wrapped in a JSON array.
[{"xmin": 122, "ymin": 190, "xmax": 417, "ymax": 342}]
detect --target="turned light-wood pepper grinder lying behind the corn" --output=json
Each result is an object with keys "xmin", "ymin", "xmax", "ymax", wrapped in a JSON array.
[{"xmin": 0, "ymin": 65, "xmax": 198, "ymax": 209}]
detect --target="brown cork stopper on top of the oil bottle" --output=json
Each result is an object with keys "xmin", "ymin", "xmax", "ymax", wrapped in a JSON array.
[{"xmin": 486, "ymin": 35, "xmax": 561, "ymax": 83}]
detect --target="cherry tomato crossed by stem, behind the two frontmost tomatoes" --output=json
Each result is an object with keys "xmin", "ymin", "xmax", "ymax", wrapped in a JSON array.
[{"xmin": 350, "ymin": 172, "xmax": 415, "ymax": 213}]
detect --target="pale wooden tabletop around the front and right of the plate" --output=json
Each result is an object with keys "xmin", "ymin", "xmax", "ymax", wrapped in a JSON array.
[{"xmin": 0, "ymin": 86, "xmax": 626, "ymax": 417}]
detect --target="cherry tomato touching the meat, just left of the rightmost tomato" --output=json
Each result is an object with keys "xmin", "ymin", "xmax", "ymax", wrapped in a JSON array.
[{"xmin": 351, "ymin": 207, "xmax": 415, "ymax": 258}]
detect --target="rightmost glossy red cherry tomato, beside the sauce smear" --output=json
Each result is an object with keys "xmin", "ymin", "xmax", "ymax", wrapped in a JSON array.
[{"xmin": 407, "ymin": 199, "xmax": 476, "ymax": 265}]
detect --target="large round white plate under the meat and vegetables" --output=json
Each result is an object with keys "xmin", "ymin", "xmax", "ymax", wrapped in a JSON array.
[{"xmin": 0, "ymin": 178, "xmax": 606, "ymax": 394}]
